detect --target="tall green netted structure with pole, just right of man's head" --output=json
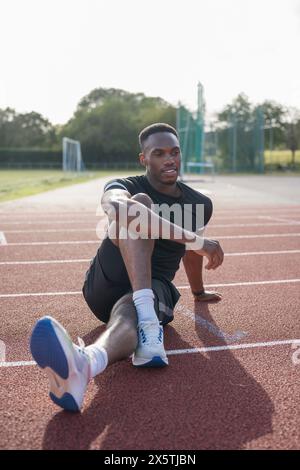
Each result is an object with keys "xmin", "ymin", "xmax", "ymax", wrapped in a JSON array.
[{"xmin": 176, "ymin": 82, "xmax": 205, "ymax": 174}]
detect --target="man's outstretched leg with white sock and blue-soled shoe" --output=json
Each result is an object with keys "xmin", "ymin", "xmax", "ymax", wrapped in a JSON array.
[{"xmin": 30, "ymin": 293, "xmax": 137, "ymax": 411}]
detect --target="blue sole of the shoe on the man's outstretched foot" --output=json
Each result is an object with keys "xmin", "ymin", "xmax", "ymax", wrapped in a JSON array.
[{"xmin": 30, "ymin": 317, "xmax": 80, "ymax": 412}]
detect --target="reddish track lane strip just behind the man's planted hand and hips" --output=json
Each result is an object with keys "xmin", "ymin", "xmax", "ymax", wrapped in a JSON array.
[{"xmin": 0, "ymin": 253, "xmax": 300, "ymax": 294}]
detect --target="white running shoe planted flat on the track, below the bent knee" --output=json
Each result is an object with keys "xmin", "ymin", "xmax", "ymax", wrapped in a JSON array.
[{"xmin": 132, "ymin": 322, "xmax": 169, "ymax": 367}]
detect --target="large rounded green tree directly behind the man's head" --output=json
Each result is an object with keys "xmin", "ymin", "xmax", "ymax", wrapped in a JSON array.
[{"xmin": 61, "ymin": 88, "xmax": 176, "ymax": 164}]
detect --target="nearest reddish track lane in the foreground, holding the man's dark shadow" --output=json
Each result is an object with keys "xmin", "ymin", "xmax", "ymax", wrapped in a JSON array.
[{"xmin": 0, "ymin": 346, "xmax": 300, "ymax": 450}]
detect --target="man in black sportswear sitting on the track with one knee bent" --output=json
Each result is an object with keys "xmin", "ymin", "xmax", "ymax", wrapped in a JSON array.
[{"xmin": 30, "ymin": 123, "xmax": 223, "ymax": 411}]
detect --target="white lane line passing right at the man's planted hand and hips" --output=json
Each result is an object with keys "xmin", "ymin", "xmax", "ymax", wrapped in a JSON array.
[{"xmin": 0, "ymin": 279, "xmax": 300, "ymax": 299}]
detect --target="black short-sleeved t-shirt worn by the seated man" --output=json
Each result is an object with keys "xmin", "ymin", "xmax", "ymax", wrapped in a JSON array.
[{"xmin": 104, "ymin": 175, "xmax": 213, "ymax": 281}]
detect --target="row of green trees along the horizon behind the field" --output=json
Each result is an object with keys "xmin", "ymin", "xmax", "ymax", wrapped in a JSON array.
[{"xmin": 0, "ymin": 88, "xmax": 300, "ymax": 164}]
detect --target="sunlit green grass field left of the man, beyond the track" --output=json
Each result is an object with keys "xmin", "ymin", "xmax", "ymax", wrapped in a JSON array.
[{"xmin": 0, "ymin": 170, "xmax": 139, "ymax": 202}]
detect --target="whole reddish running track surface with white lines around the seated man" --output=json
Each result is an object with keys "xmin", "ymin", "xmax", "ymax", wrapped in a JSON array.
[{"xmin": 0, "ymin": 176, "xmax": 300, "ymax": 450}]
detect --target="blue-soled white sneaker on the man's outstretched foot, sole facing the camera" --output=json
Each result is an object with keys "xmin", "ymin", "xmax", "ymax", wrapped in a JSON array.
[{"xmin": 30, "ymin": 316, "xmax": 91, "ymax": 411}]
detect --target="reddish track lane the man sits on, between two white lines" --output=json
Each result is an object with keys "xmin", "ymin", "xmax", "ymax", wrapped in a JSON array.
[{"xmin": 0, "ymin": 283, "xmax": 300, "ymax": 362}]
